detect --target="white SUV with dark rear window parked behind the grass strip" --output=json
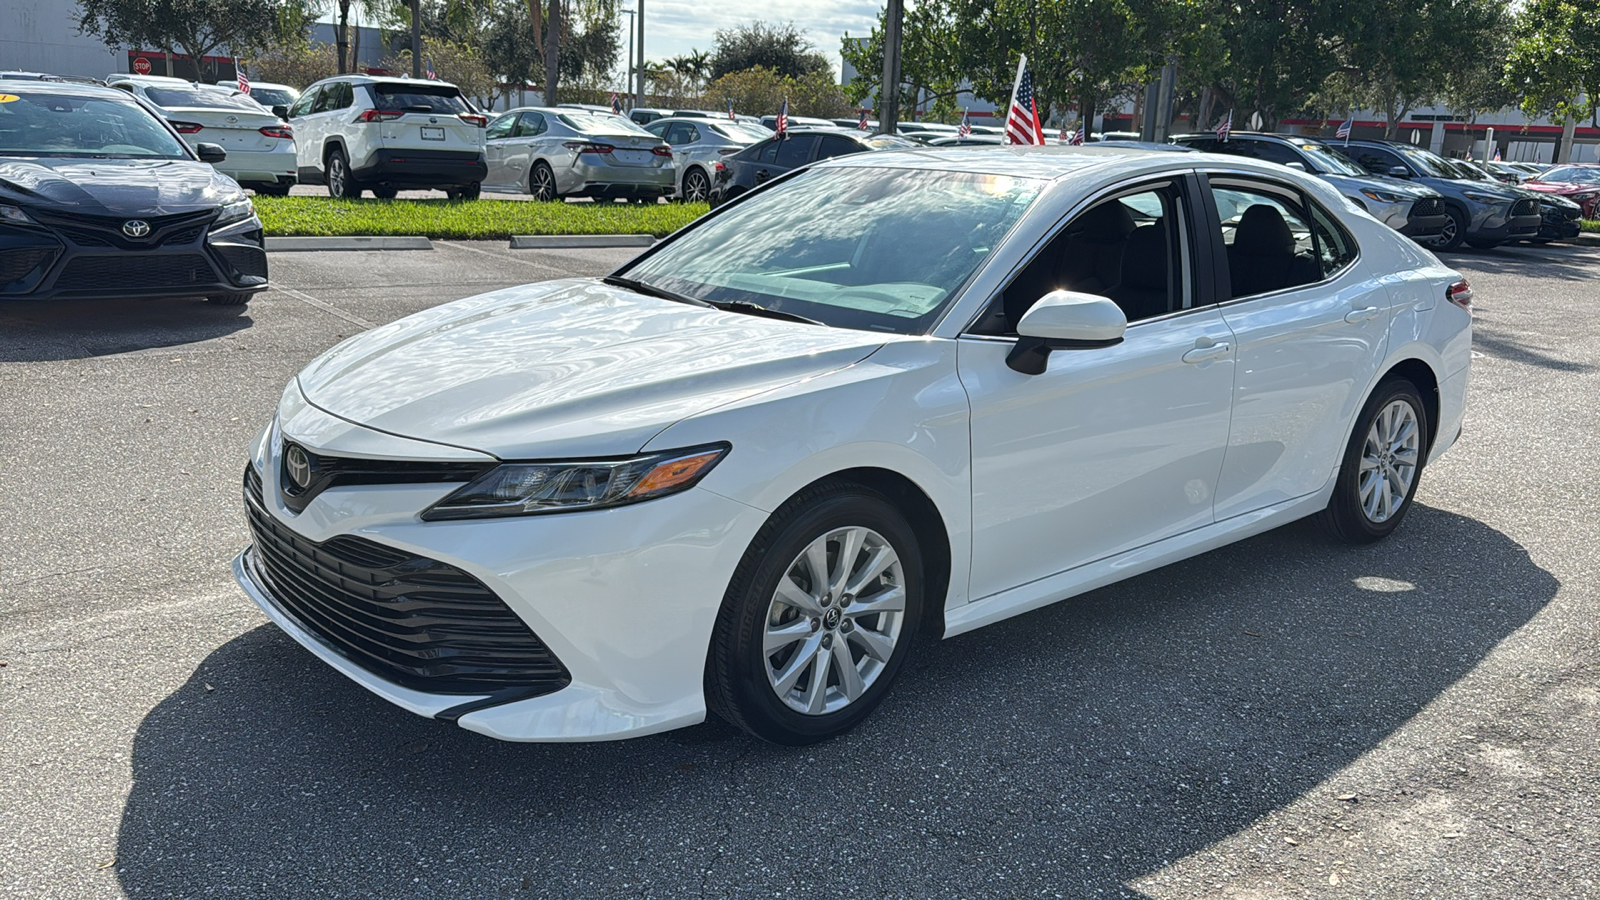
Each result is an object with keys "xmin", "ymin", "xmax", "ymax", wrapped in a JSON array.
[{"xmin": 290, "ymin": 75, "xmax": 488, "ymax": 200}]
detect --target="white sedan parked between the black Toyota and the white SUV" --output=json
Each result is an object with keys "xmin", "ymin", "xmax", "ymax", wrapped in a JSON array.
[{"xmin": 109, "ymin": 75, "xmax": 298, "ymax": 197}]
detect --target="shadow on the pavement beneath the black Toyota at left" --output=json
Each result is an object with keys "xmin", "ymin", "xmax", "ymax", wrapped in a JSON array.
[{"xmin": 0, "ymin": 298, "xmax": 253, "ymax": 362}]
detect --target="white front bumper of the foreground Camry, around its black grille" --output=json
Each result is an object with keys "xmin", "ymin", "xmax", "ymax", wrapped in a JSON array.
[{"xmin": 234, "ymin": 407, "xmax": 766, "ymax": 741}]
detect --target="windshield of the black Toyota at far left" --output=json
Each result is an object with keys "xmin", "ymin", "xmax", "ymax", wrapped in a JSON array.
[{"xmin": 0, "ymin": 88, "xmax": 190, "ymax": 160}]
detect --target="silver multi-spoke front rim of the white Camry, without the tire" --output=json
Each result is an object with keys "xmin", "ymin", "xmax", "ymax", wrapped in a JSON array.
[{"xmin": 763, "ymin": 525, "xmax": 906, "ymax": 716}]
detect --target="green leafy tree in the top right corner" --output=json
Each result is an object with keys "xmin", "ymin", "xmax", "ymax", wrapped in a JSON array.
[{"xmin": 1506, "ymin": 0, "xmax": 1600, "ymax": 122}]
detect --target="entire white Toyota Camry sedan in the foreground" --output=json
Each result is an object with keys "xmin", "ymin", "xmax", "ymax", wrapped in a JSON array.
[{"xmin": 234, "ymin": 147, "xmax": 1470, "ymax": 743}]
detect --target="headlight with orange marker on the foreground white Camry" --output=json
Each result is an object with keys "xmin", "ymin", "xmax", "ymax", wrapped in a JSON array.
[{"xmin": 422, "ymin": 444, "xmax": 730, "ymax": 522}]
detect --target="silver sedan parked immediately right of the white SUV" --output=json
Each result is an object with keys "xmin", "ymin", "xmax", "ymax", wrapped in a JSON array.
[{"xmin": 483, "ymin": 107, "xmax": 675, "ymax": 200}]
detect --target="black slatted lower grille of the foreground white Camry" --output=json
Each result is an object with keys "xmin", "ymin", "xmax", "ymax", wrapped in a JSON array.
[{"xmin": 245, "ymin": 466, "xmax": 571, "ymax": 697}]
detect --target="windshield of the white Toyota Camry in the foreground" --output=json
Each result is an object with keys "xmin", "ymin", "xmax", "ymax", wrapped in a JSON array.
[{"xmin": 627, "ymin": 167, "xmax": 1045, "ymax": 335}]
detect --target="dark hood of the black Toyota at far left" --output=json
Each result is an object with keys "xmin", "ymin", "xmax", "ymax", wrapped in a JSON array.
[{"xmin": 0, "ymin": 157, "xmax": 243, "ymax": 216}]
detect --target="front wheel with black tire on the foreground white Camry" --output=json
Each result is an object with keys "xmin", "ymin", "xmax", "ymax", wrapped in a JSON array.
[{"xmin": 706, "ymin": 482, "xmax": 923, "ymax": 746}]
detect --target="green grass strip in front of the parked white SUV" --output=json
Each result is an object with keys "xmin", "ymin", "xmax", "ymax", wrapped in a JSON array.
[{"xmin": 254, "ymin": 197, "xmax": 709, "ymax": 240}]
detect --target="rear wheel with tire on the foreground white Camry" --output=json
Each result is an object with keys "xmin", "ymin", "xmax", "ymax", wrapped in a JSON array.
[{"xmin": 1318, "ymin": 380, "xmax": 1429, "ymax": 544}]
